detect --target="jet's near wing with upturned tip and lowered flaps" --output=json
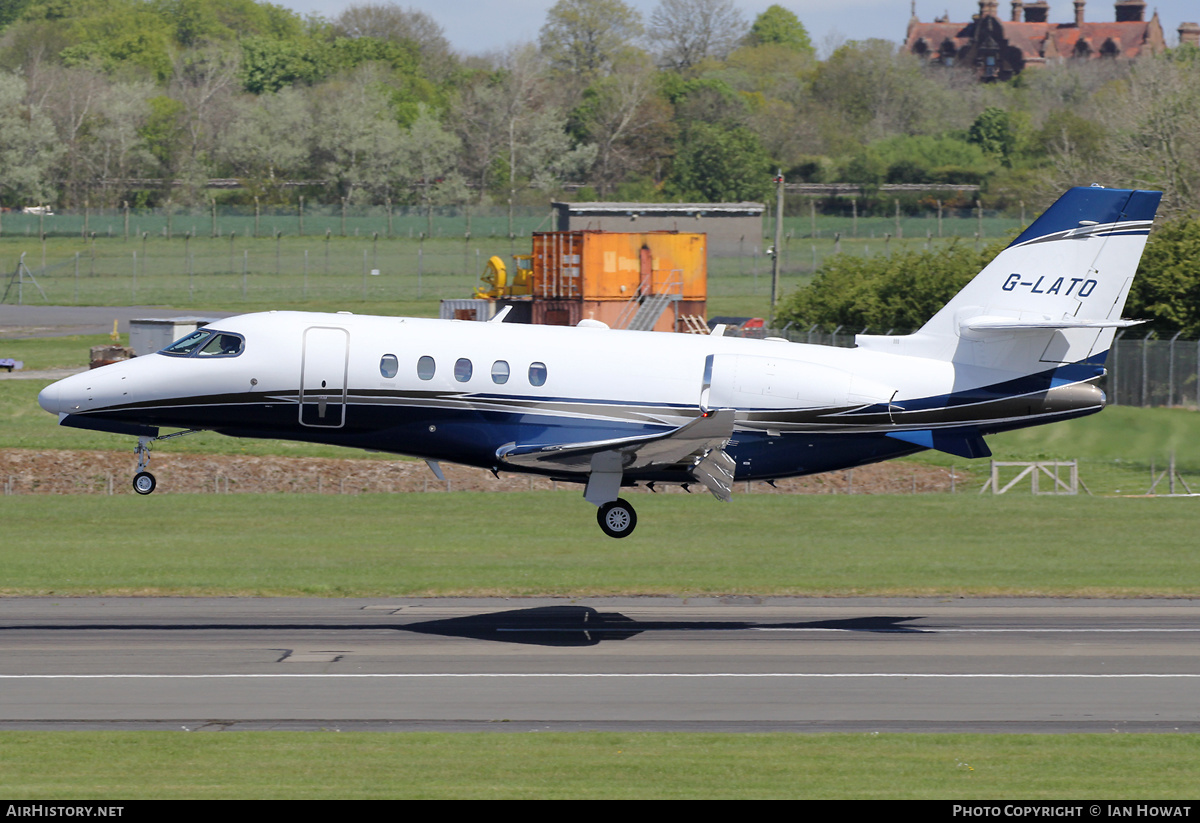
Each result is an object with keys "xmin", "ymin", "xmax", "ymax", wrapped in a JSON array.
[{"xmin": 496, "ymin": 409, "xmax": 733, "ymax": 499}]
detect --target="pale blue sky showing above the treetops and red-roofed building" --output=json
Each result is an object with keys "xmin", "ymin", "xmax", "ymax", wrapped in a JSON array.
[{"xmin": 271, "ymin": 0, "xmax": 1200, "ymax": 56}]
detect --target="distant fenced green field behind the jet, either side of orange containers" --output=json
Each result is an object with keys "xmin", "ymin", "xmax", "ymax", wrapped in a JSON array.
[{"xmin": 0, "ymin": 218, "xmax": 1015, "ymax": 317}]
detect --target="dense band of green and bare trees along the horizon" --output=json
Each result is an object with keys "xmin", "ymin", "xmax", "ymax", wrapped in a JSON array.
[{"xmin": 0, "ymin": 0, "xmax": 1200, "ymax": 220}]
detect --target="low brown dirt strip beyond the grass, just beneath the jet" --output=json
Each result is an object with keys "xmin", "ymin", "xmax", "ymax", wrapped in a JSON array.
[{"xmin": 0, "ymin": 449, "xmax": 970, "ymax": 494}]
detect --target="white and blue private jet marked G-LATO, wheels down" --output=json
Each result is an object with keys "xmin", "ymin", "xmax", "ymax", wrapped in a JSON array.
[{"xmin": 38, "ymin": 186, "xmax": 1162, "ymax": 537}]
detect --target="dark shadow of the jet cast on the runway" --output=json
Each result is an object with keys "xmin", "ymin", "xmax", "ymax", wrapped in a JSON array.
[{"xmin": 402, "ymin": 606, "xmax": 925, "ymax": 645}]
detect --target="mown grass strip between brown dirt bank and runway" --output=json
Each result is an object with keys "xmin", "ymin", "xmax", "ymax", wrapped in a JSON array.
[{"xmin": 0, "ymin": 491, "xmax": 1200, "ymax": 596}]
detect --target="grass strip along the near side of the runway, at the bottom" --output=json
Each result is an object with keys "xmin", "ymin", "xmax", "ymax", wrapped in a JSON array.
[{"xmin": 0, "ymin": 732, "xmax": 1200, "ymax": 801}]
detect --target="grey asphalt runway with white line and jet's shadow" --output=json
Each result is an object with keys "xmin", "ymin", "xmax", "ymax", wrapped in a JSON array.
[{"xmin": 0, "ymin": 597, "xmax": 1200, "ymax": 732}]
